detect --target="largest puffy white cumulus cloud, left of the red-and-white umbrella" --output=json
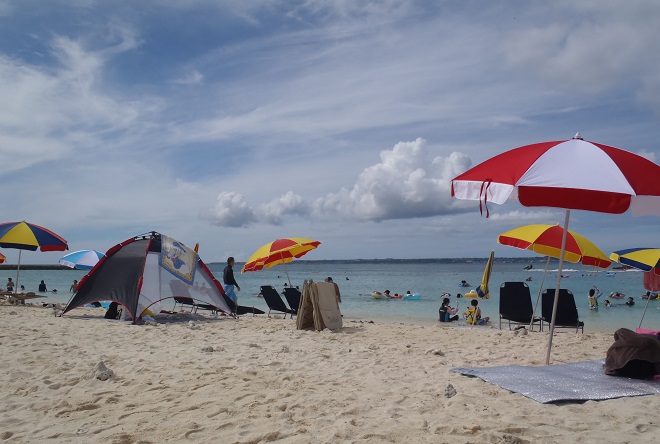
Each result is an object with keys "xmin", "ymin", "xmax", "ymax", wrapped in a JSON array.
[{"xmin": 314, "ymin": 139, "xmax": 471, "ymax": 221}]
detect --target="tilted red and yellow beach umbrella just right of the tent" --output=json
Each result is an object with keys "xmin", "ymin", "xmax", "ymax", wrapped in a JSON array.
[{"xmin": 241, "ymin": 237, "xmax": 321, "ymax": 285}]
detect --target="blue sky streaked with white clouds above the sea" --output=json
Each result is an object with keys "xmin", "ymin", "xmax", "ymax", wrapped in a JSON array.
[{"xmin": 0, "ymin": 0, "xmax": 660, "ymax": 263}]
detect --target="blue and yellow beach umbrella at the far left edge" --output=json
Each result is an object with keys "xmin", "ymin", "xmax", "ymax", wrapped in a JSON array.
[{"xmin": 0, "ymin": 221, "xmax": 69, "ymax": 291}]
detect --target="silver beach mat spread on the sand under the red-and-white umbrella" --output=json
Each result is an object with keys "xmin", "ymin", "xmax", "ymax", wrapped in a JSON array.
[{"xmin": 451, "ymin": 359, "xmax": 660, "ymax": 404}]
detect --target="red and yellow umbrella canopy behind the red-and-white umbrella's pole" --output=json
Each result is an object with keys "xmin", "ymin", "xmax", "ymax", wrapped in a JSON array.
[{"xmin": 497, "ymin": 224, "xmax": 612, "ymax": 268}]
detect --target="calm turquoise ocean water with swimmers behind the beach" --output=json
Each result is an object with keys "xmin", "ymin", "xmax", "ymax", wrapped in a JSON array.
[{"xmin": 7, "ymin": 260, "xmax": 660, "ymax": 332}]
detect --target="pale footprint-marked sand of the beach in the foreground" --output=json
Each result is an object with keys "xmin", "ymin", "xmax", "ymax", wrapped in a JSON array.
[{"xmin": 0, "ymin": 305, "xmax": 660, "ymax": 444}]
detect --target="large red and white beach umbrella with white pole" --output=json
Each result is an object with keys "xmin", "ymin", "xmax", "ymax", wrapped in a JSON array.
[{"xmin": 451, "ymin": 134, "xmax": 660, "ymax": 364}]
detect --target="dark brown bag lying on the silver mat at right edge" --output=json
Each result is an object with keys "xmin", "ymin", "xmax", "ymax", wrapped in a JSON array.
[{"xmin": 603, "ymin": 328, "xmax": 660, "ymax": 379}]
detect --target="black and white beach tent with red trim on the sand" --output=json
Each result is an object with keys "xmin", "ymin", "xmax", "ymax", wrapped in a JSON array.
[{"xmin": 63, "ymin": 232, "xmax": 231, "ymax": 322}]
